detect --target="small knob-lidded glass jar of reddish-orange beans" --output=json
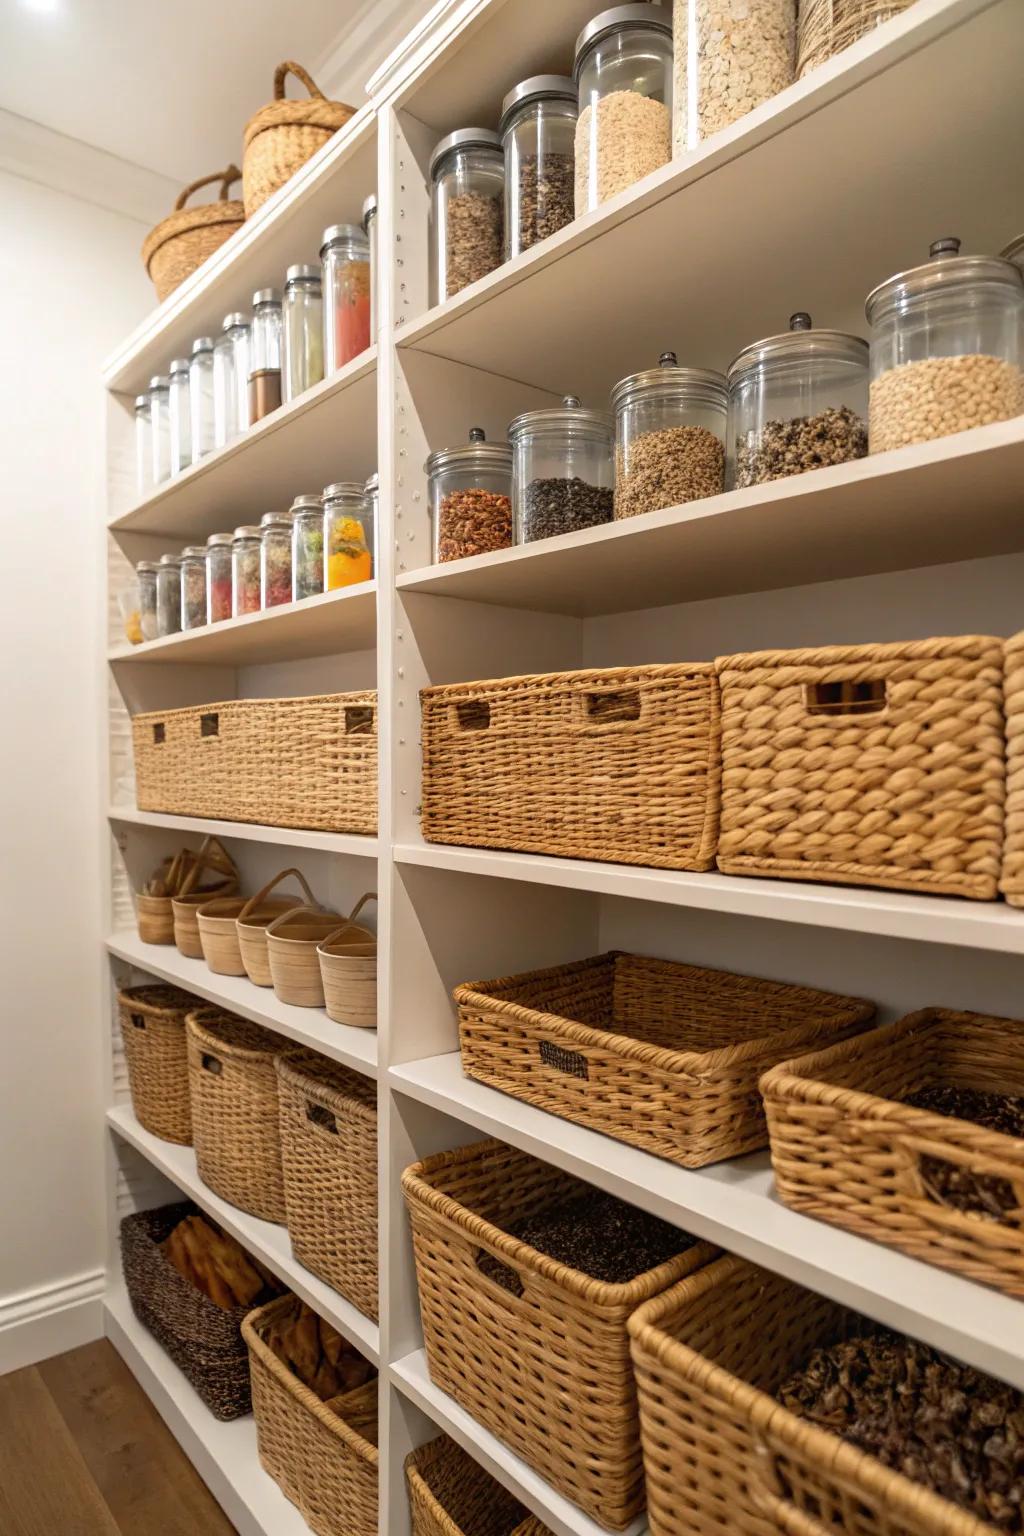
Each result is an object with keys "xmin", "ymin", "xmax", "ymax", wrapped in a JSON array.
[{"xmin": 427, "ymin": 427, "xmax": 513, "ymax": 562}]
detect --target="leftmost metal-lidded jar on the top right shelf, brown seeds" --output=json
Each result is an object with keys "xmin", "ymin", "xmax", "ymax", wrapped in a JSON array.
[{"xmin": 430, "ymin": 127, "xmax": 505, "ymax": 304}]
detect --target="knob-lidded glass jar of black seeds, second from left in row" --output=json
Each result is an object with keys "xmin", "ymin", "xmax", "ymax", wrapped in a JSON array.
[{"xmin": 508, "ymin": 395, "xmax": 616, "ymax": 544}]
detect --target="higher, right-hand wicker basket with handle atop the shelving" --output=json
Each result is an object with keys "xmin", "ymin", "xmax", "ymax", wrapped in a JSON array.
[{"xmin": 243, "ymin": 60, "xmax": 356, "ymax": 218}]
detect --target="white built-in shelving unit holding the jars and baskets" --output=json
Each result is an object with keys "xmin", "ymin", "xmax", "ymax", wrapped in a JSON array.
[{"xmin": 101, "ymin": 0, "xmax": 1024, "ymax": 1536}]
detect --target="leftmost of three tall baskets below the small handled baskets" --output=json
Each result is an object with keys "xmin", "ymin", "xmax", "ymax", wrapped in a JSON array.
[{"xmin": 117, "ymin": 983, "xmax": 195, "ymax": 1147}]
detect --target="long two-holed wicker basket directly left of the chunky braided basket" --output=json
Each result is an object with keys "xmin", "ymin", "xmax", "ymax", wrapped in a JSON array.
[{"xmin": 421, "ymin": 665, "xmax": 720, "ymax": 869}]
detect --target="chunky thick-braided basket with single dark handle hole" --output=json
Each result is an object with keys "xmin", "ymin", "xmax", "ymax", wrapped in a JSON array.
[{"xmin": 717, "ymin": 634, "xmax": 1004, "ymax": 900}]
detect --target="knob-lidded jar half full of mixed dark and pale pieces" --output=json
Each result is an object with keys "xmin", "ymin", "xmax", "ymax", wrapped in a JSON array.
[{"xmin": 729, "ymin": 312, "xmax": 867, "ymax": 485}]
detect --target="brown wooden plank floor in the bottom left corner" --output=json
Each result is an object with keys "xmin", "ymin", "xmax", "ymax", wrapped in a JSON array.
[{"xmin": 0, "ymin": 1339, "xmax": 235, "ymax": 1536}]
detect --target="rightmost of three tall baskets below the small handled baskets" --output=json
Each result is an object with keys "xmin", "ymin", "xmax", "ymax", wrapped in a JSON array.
[{"xmin": 278, "ymin": 1051, "xmax": 379, "ymax": 1322}]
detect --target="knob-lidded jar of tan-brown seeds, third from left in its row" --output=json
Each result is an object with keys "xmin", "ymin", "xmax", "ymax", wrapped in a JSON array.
[{"xmin": 611, "ymin": 352, "xmax": 729, "ymax": 519}]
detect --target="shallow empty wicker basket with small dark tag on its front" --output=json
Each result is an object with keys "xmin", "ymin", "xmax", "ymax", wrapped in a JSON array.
[{"xmin": 454, "ymin": 951, "xmax": 875, "ymax": 1167}]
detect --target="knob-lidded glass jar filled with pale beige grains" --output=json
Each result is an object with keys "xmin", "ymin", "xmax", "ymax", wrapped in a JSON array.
[{"xmin": 866, "ymin": 240, "xmax": 1024, "ymax": 453}]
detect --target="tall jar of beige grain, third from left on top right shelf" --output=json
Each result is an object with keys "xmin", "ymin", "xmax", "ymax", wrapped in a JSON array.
[{"xmin": 574, "ymin": 5, "xmax": 672, "ymax": 218}]
